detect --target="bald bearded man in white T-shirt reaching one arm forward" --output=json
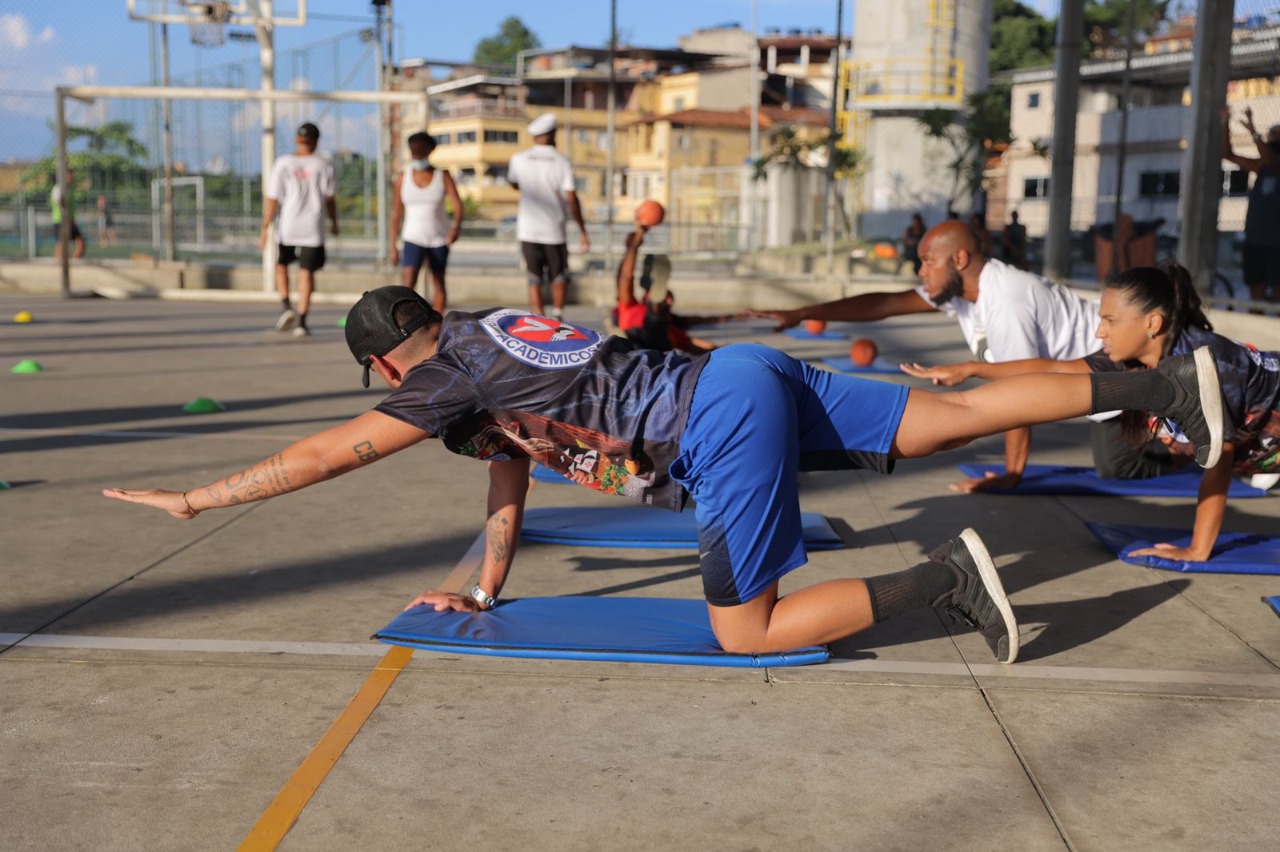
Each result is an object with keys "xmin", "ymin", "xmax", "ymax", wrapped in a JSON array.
[{"xmin": 746, "ymin": 220, "xmax": 1101, "ymax": 493}]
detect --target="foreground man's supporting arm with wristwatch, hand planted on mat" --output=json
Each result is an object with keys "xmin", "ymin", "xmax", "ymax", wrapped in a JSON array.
[{"xmin": 404, "ymin": 458, "xmax": 529, "ymax": 613}]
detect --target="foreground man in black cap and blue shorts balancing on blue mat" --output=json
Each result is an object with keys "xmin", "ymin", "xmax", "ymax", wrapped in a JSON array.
[{"xmin": 104, "ymin": 285, "xmax": 1222, "ymax": 663}]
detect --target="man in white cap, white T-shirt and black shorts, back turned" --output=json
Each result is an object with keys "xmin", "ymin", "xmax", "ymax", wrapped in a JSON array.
[{"xmin": 507, "ymin": 113, "xmax": 591, "ymax": 319}]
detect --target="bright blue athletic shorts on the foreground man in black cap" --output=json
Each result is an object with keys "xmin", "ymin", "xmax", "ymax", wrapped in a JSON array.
[{"xmin": 671, "ymin": 343, "xmax": 908, "ymax": 606}]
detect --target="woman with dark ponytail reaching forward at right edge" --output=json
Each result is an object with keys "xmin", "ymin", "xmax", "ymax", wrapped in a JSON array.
[{"xmin": 902, "ymin": 264, "xmax": 1280, "ymax": 562}]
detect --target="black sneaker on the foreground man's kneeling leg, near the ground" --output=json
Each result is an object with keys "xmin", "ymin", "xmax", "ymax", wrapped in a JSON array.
[{"xmin": 929, "ymin": 530, "xmax": 1018, "ymax": 663}]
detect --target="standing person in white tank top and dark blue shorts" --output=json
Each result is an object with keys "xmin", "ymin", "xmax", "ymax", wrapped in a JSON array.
[{"xmin": 390, "ymin": 132, "xmax": 462, "ymax": 313}]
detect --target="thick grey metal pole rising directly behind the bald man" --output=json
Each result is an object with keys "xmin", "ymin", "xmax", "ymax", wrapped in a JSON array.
[{"xmin": 1044, "ymin": 0, "xmax": 1084, "ymax": 279}]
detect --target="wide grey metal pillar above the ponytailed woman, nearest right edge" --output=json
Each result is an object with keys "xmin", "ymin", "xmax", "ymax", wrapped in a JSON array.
[{"xmin": 1178, "ymin": 0, "xmax": 1235, "ymax": 292}]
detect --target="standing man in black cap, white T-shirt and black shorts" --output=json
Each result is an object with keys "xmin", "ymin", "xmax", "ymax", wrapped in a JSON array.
[{"xmin": 257, "ymin": 122, "xmax": 338, "ymax": 338}]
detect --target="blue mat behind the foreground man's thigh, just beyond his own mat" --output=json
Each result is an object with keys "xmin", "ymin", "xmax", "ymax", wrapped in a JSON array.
[{"xmin": 521, "ymin": 505, "xmax": 845, "ymax": 550}]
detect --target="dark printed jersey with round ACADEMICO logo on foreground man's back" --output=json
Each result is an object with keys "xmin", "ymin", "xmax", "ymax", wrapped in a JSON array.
[{"xmin": 375, "ymin": 308, "xmax": 707, "ymax": 510}]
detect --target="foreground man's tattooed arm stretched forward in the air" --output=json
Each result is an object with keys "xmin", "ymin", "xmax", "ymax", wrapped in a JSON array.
[{"xmin": 102, "ymin": 411, "xmax": 429, "ymax": 519}]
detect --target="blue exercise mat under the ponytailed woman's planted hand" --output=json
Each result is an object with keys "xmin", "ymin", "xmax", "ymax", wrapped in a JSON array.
[{"xmin": 1088, "ymin": 521, "xmax": 1280, "ymax": 574}]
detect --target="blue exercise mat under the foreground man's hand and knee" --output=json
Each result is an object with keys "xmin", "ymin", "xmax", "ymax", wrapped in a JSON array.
[{"xmin": 374, "ymin": 596, "xmax": 828, "ymax": 669}]
